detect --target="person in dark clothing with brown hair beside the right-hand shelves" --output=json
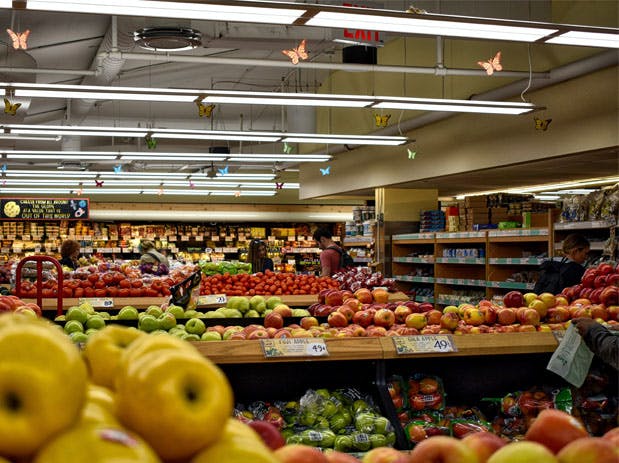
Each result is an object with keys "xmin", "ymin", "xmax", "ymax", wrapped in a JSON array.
[{"xmin": 533, "ymin": 233, "xmax": 590, "ymax": 294}]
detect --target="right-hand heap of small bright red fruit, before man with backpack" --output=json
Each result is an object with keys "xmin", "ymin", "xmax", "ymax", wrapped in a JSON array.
[{"xmin": 200, "ymin": 270, "xmax": 339, "ymax": 296}]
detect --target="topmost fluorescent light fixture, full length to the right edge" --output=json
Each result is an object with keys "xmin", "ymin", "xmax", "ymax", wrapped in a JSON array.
[{"xmin": 19, "ymin": 0, "xmax": 619, "ymax": 48}]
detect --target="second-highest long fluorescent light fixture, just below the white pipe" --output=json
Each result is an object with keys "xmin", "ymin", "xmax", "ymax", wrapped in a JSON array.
[{"xmin": 0, "ymin": 82, "xmax": 544, "ymax": 114}]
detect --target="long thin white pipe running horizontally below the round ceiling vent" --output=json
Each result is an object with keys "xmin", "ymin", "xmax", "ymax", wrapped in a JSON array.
[{"xmin": 98, "ymin": 51, "xmax": 549, "ymax": 79}]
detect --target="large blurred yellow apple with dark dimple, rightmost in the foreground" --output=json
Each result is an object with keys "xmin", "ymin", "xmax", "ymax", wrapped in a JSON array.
[{"xmin": 116, "ymin": 344, "xmax": 233, "ymax": 461}]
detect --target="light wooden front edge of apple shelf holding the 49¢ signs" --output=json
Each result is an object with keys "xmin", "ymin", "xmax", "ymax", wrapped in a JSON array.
[{"xmin": 192, "ymin": 332, "xmax": 557, "ymax": 364}]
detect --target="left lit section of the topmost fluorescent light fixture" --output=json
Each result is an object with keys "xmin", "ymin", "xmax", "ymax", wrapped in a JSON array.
[{"xmin": 27, "ymin": 0, "xmax": 305, "ymax": 25}]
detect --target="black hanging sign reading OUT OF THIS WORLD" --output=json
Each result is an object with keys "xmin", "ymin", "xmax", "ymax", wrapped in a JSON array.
[{"xmin": 0, "ymin": 198, "xmax": 90, "ymax": 220}]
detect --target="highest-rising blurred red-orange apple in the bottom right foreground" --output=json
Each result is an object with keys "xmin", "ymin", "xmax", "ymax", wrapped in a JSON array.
[{"xmin": 525, "ymin": 409, "xmax": 589, "ymax": 453}]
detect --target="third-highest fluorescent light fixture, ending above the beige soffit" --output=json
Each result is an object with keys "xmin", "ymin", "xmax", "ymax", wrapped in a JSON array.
[{"xmin": 0, "ymin": 124, "xmax": 409, "ymax": 146}]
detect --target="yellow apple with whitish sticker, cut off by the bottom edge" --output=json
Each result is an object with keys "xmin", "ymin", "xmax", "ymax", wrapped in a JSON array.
[{"xmin": 33, "ymin": 423, "xmax": 161, "ymax": 463}]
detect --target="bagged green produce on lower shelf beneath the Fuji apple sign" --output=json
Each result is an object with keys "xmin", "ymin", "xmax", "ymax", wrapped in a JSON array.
[{"xmin": 235, "ymin": 388, "xmax": 395, "ymax": 452}]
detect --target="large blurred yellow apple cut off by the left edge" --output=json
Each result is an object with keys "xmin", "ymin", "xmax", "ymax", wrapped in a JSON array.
[{"xmin": 0, "ymin": 314, "xmax": 87, "ymax": 459}]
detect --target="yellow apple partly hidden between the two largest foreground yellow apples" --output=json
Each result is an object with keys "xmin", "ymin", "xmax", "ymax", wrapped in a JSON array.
[{"xmin": 83, "ymin": 325, "xmax": 146, "ymax": 389}]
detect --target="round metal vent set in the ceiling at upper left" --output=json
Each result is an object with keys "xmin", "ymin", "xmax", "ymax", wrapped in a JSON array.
[{"xmin": 133, "ymin": 27, "xmax": 202, "ymax": 52}]
